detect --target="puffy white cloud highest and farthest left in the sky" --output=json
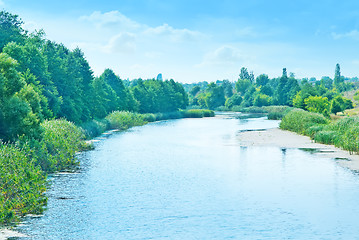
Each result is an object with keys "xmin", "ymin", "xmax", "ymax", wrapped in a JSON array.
[{"xmin": 80, "ymin": 11, "xmax": 141, "ymax": 29}]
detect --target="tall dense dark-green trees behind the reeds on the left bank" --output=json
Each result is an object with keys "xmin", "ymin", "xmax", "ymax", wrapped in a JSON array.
[{"xmin": 0, "ymin": 11, "xmax": 188, "ymax": 141}]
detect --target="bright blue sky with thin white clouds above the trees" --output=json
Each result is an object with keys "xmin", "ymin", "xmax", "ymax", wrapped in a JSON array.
[{"xmin": 0, "ymin": 0, "xmax": 359, "ymax": 82}]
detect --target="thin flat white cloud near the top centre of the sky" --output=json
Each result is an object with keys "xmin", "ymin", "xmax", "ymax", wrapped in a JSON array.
[{"xmin": 144, "ymin": 23, "xmax": 204, "ymax": 42}]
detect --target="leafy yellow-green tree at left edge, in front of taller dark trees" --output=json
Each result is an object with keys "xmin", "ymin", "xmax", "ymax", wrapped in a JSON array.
[{"xmin": 0, "ymin": 53, "xmax": 42, "ymax": 141}]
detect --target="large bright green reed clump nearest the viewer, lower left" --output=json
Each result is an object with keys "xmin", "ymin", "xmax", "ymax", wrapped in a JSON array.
[{"xmin": 0, "ymin": 144, "xmax": 47, "ymax": 224}]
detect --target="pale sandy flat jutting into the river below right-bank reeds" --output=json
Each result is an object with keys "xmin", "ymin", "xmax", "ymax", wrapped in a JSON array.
[{"xmin": 237, "ymin": 128, "xmax": 359, "ymax": 171}]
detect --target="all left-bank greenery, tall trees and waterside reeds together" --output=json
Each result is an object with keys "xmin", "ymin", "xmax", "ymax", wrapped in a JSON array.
[{"xmin": 0, "ymin": 11, "xmax": 214, "ymax": 225}]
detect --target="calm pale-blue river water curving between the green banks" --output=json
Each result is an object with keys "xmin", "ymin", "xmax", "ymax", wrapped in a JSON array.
[{"xmin": 17, "ymin": 114, "xmax": 359, "ymax": 239}]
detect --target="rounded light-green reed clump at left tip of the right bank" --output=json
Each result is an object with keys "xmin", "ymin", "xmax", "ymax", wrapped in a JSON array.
[{"xmin": 280, "ymin": 109, "xmax": 329, "ymax": 134}]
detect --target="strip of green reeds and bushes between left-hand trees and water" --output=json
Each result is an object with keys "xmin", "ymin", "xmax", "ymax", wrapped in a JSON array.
[{"xmin": 0, "ymin": 110, "xmax": 214, "ymax": 225}]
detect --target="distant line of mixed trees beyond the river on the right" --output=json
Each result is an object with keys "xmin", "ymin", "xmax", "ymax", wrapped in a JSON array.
[{"xmin": 184, "ymin": 64, "xmax": 356, "ymax": 116}]
